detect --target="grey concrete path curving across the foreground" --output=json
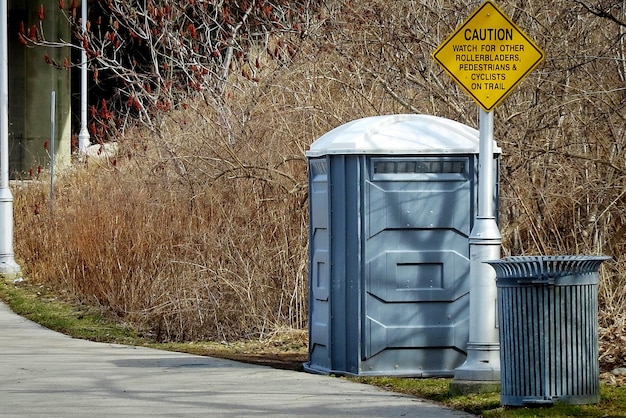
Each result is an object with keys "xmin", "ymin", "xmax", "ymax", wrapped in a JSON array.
[{"xmin": 0, "ymin": 303, "xmax": 472, "ymax": 418}]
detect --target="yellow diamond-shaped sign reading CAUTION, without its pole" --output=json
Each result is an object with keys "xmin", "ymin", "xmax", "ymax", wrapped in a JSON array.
[{"xmin": 433, "ymin": 0, "xmax": 545, "ymax": 112}]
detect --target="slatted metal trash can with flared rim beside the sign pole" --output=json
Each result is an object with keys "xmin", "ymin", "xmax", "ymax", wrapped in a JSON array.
[{"xmin": 487, "ymin": 255, "xmax": 611, "ymax": 406}]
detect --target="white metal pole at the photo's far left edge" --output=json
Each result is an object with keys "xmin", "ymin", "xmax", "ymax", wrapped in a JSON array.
[{"xmin": 0, "ymin": 0, "xmax": 21, "ymax": 277}]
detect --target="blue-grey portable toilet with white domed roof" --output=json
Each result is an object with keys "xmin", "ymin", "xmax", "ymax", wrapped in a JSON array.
[{"xmin": 305, "ymin": 115, "xmax": 500, "ymax": 376}]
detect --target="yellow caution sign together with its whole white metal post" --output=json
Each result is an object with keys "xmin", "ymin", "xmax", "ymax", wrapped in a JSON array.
[{"xmin": 433, "ymin": 0, "xmax": 544, "ymax": 393}]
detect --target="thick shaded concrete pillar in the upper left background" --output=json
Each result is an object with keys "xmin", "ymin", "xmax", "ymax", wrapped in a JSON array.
[{"xmin": 8, "ymin": 0, "xmax": 71, "ymax": 178}]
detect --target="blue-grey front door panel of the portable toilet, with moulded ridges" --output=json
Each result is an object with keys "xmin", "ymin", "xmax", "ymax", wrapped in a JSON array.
[{"xmin": 362, "ymin": 156, "xmax": 475, "ymax": 372}]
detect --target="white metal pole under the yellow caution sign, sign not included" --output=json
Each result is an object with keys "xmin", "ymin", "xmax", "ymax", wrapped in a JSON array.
[{"xmin": 453, "ymin": 109, "xmax": 502, "ymax": 392}]
